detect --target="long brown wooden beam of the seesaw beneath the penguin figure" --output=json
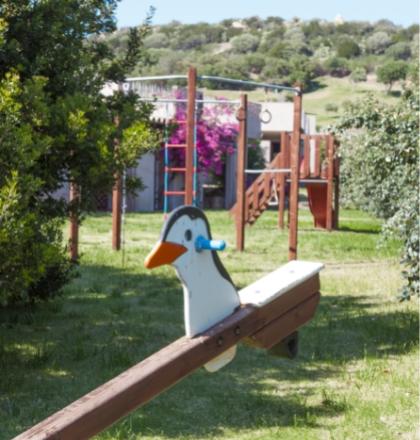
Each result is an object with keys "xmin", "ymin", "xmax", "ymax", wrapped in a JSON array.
[{"xmin": 15, "ymin": 274, "xmax": 320, "ymax": 440}]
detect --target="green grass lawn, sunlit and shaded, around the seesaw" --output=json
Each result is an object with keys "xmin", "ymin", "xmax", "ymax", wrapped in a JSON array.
[{"xmin": 0, "ymin": 210, "xmax": 419, "ymax": 440}]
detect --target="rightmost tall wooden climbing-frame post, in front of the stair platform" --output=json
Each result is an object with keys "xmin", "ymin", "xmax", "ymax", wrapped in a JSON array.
[{"xmin": 289, "ymin": 88, "xmax": 302, "ymax": 260}]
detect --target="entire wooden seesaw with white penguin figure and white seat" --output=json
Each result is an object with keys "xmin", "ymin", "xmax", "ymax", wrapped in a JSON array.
[{"xmin": 15, "ymin": 206, "xmax": 322, "ymax": 440}]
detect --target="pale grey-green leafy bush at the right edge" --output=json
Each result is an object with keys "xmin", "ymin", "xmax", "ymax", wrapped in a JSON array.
[{"xmin": 336, "ymin": 89, "xmax": 419, "ymax": 298}]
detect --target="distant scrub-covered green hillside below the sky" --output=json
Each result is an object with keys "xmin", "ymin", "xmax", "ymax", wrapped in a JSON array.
[{"xmin": 105, "ymin": 17, "xmax": 419, "ymax": 125}]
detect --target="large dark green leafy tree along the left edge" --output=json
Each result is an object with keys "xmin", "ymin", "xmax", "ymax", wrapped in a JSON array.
[{"xmin": 0, "ymin": 0, "xmax": 155, "ymax": 304}]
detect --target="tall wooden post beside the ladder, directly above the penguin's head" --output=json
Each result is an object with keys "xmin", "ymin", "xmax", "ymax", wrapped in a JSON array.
[{"xmin": 184, "ymin": 67, "xmax": 197, "ymax": 205}]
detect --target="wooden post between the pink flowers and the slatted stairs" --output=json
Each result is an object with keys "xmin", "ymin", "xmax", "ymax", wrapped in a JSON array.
[{"xmin": 235, "ymin": 94, "xmax": 248, "ymax": 252}]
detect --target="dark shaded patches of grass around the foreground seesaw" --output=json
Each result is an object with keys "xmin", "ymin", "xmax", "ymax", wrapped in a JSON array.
[{"xmin": 0, "ymin": 265, "xmax": 418, "ymax": 439}]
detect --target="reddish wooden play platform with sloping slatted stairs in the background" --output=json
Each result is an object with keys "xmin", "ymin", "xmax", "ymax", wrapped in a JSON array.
[{"xmin": 231, "ymin": 129, "xmax": 339, "ymax": 250}]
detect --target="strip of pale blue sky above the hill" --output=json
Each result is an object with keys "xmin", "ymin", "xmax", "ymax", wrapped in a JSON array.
[{"xmin": 117, "ymin": 0, "xmax": 419, "ymax": 27}]
